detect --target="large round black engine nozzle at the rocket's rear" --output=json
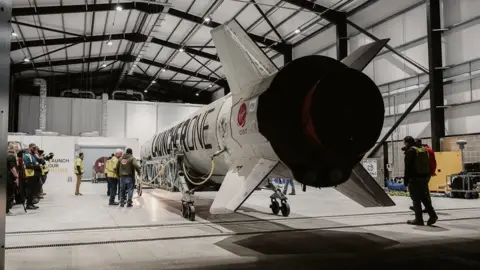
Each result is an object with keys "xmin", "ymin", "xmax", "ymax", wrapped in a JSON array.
[{"xmin": 258, "ymin": 53, "xmax": 385, "ymax": 187}]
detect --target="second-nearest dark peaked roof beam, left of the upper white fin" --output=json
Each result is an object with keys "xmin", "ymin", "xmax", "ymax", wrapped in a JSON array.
[{"xmin": 11, "ymin": 33, "xmax": 220, "ymax": 62}]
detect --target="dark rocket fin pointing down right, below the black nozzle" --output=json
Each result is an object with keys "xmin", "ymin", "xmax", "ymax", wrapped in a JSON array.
[{"xmin": 335, "ymin": 163, "xmax": 395, "ymax": 207}]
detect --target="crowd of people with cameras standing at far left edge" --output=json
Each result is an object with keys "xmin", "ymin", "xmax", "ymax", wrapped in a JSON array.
[{"xmin": 6, "ymin": 143, "xmax": 54, "ymax": 215}]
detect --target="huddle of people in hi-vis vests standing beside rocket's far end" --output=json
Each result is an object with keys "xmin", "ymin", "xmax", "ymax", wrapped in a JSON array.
[{"xmin": 101, "ymin": 148, "xmax": 140, "ymax": 207}]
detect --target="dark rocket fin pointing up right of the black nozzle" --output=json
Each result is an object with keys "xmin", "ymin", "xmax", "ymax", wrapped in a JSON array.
[{"xmin": 341, "ymin": 38, "xmax": 390, "ymax": 71}]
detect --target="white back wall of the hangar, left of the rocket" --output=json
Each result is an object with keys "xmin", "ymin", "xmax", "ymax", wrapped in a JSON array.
[{"xmin": 18, "ymin": 96, "xmax": 203, "ymax": 145}]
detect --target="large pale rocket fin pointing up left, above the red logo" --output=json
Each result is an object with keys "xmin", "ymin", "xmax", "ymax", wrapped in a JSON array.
[{"xmin": 211, "ymin": 20, "xmax": 278, "ymax": 94}]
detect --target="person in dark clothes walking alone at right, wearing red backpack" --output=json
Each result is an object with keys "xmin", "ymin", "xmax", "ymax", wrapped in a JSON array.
[{"xmin": 403, "ymin": 136, "xmax": 438, "ymax": 226}]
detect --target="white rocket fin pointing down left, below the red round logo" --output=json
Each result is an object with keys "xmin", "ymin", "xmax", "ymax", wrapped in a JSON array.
[{"xmin": 210, "ymin": 158, "xmax": 278, "ymax": 214}]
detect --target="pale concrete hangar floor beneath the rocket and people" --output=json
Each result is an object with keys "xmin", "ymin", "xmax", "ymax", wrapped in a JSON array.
[{"xmin": 6, "ymin": 181, "xmax": 480, "ymax": 270}]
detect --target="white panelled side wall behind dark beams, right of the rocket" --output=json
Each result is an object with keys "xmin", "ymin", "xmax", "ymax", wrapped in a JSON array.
[{"xmin": 293, "ymin": 0, "xmax": 480, "ymax": 140}]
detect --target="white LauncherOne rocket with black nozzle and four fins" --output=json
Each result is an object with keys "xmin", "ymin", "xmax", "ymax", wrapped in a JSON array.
[{"xmin": 141, "ymin": 21, "xmax": 394, "ymax": 219}]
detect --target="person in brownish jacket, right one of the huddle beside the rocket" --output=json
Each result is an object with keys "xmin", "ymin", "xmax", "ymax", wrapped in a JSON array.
[{"xmin": 116, "ymin": 148, "xmax": 140, "ymax": 207}]
